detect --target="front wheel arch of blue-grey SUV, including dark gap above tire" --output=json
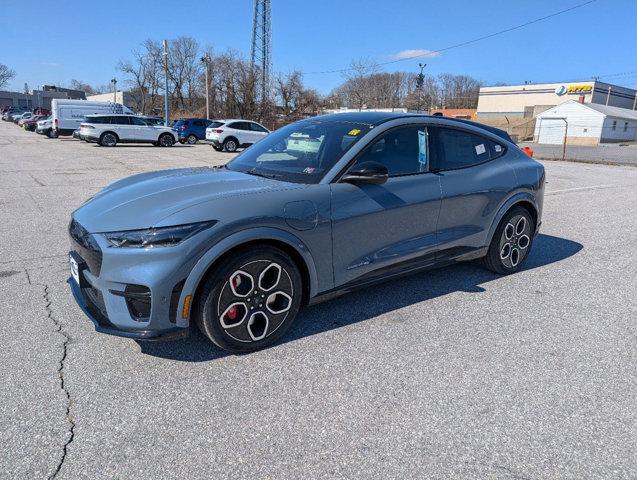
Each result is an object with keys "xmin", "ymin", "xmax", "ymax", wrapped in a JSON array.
[{"xmin": 177, "ymin": 227, "xmax": 318, "ymax": 326}]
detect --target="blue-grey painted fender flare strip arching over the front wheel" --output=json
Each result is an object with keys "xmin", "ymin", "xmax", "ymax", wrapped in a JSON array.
[{"xmin": 177, "ymin": 227, "xmax": 318, "ymax": 327}]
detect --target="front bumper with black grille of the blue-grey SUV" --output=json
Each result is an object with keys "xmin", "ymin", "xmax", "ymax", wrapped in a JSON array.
[{"xmin": 68, "ymin": 221, "xmax": 194, "ymax": 340}]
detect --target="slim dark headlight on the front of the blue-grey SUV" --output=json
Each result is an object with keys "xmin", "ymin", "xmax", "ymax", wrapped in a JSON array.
[{"xmin": 103, "ymin": 220, "xmax": 217, "ymax": 248}]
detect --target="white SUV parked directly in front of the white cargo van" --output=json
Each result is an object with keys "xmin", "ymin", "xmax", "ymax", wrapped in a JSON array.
[{"xmin": 80, "ymin": 115, "xmax": 177, "ymax": 147}]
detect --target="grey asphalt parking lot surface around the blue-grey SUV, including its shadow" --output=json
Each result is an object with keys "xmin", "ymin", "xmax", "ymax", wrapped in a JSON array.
[{"xmin": 0, "ymin": 122, "xmax": 637, "ymax": 479}]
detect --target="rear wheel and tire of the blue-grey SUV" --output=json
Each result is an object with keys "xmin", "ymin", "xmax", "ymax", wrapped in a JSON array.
[{"xmin": 482, "ymin": 207, "xmax": 535, "ymax": 275}]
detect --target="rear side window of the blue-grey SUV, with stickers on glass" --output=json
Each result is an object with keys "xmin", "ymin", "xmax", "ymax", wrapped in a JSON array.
[{"xmin": 432, "ymin": 128, "xmax": 492, "ymax": 170}]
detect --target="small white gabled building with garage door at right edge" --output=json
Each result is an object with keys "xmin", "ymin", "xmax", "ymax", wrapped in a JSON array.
[{"xmin": 534, "ymin": 100, "xmax": 637, "ymax": 145}]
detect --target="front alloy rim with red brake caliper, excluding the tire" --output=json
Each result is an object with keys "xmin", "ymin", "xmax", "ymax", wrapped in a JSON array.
[{"xmin": 217, "ymin": 260, "xmax": 294, "ymax": 343}]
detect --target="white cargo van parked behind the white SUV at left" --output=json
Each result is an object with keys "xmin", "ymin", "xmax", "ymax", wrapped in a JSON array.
[{"xmin": 50, "ymin": 98, "xmax": 134, "ymax": 137}]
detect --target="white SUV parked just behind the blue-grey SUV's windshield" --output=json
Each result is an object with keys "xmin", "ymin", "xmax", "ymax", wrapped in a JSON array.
[{"xmin": 206, "ymin": 119, "xmax": 270, "ymax": 152}]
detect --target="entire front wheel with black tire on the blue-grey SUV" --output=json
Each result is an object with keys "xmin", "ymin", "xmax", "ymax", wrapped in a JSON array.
[{"xmin": 194, "ymin": 245, "xmax": 303, "ymax": 353}]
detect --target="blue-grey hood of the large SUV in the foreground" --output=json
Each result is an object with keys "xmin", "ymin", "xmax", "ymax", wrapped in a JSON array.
[{"xmin": 73, "ymin": 167, "xmax": 299, "ymax": 233}]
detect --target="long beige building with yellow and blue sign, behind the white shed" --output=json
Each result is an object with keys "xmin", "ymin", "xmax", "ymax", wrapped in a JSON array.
[{"xmin": 477, "ymin": 81, "xmax": 637, "ymax": 121}]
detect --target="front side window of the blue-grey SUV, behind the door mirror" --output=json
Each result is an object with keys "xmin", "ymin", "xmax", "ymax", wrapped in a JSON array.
[{"xmin": 356, "ymin": 126, "xmax": 428, "ymax": 177}]
